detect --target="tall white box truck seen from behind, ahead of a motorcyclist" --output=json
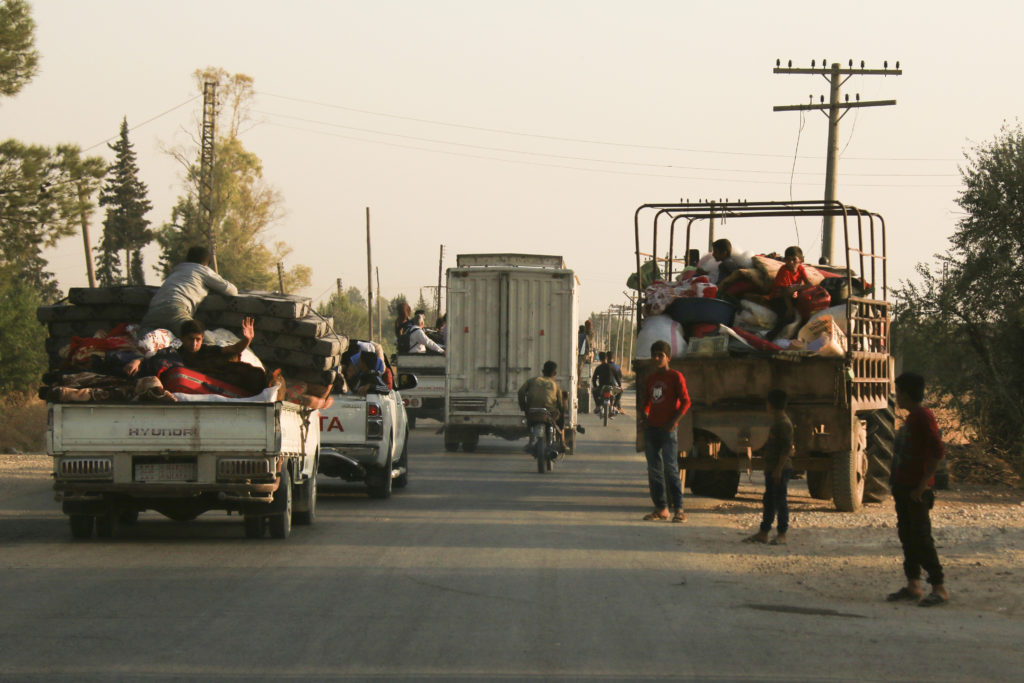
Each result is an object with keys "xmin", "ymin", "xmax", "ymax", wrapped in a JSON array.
[{"xmin": 444, "ymin": 254, "xmax": 579, "ymax": 453}]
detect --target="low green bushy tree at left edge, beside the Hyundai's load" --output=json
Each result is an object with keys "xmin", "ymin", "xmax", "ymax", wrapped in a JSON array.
[{"xmin": 0, "ymin": 264, "xmax": 47, "ymax": 395}]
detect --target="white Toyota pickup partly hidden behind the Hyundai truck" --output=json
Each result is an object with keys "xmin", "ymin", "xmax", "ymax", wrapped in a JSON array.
[{"xmin": 319, "ymin": 358, "xmax": 417, "ymax": 498}]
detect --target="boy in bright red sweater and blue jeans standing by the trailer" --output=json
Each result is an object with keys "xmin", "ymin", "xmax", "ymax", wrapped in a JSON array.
[{"xmin": 639, "ymin": 340, "xmax": 690, "ymax": 522}]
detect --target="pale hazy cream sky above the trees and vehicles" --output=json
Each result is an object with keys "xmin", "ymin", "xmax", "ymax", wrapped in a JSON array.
[{"xmin": 0, "ymin": 0, "xmax": 1024, "ymax": 314}]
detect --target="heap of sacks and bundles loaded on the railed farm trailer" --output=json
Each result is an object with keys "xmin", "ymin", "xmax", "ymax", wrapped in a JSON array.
[{"xmin": 637, "ymin": 252, "xmax": 870, "ymax": 357}]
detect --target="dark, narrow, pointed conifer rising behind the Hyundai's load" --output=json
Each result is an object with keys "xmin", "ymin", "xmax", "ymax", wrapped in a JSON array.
[{"xmin": 96, "ymin": 119, "xmax": 154, "ymax": 285}]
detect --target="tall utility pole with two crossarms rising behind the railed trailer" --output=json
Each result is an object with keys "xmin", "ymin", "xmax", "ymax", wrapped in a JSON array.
[{"xmin": 772, "ymin": 59, "xmax": 903, "ymax": 263}]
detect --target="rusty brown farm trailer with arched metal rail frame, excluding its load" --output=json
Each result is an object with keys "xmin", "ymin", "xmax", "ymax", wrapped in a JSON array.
[{"xmin": 634, "ymin": 201, "xmax": 894, "ymax": 511}]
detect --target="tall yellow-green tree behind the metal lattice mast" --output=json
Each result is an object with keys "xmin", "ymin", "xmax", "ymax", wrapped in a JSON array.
[{"xmin": 157, "ymin": 69, "xmax": 311, "ymax": 292}]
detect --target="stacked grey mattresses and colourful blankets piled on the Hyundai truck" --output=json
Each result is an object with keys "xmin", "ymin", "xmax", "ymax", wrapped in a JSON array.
[{"xmin": 36, "ymin": 287, "xmax": 348, "ymax": 408}]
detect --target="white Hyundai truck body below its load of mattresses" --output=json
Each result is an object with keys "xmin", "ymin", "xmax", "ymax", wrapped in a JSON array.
[{"xmin": 46, "ymin": 401, "xmax": 319, "ymax": 539}]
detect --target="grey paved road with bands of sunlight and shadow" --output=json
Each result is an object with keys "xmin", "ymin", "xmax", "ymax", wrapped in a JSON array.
[{"xmin": 0, "ymin": 397, "xmax": 1024, "ymax": 681}]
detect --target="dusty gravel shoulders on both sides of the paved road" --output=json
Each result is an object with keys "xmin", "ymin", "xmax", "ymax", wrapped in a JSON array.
[{"xmin": 8, "ymin": 448, "xmax": 1024, "ymax": 616}]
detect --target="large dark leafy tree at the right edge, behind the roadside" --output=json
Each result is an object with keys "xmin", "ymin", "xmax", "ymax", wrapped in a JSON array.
[{"xmin": 893, "ymin": 125, "xmax": 1024, "ymax": 469}]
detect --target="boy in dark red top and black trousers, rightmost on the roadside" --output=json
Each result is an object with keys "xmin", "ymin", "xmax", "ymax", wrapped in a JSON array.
[{"xmin": 886, "ymin": 373, "xmax": 949, "ymax": 607}]
